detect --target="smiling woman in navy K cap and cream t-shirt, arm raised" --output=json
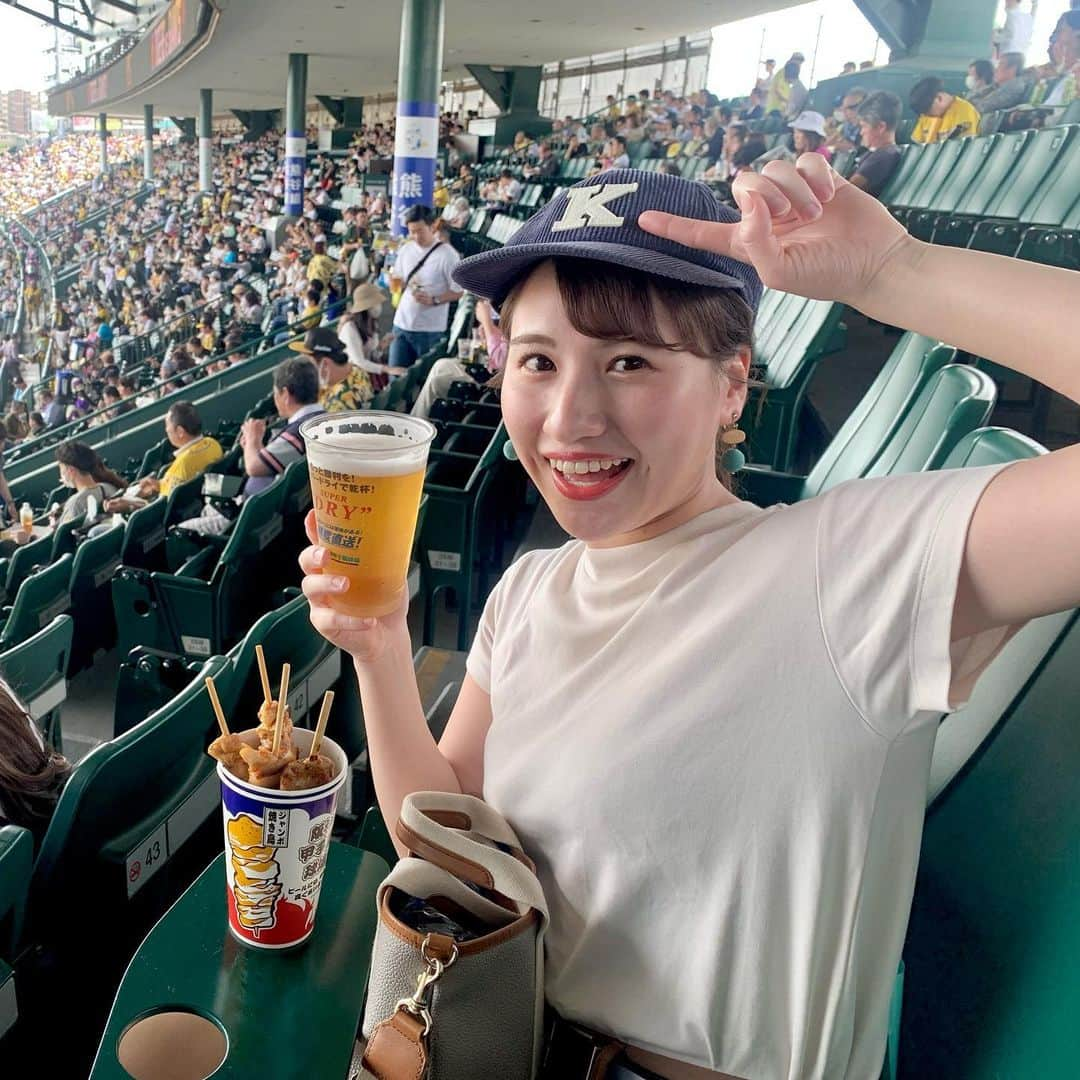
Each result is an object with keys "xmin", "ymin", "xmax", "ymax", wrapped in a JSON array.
[{"xmin": 301, "ymin": 162, "xmax": 1080, "ymax": 1080}]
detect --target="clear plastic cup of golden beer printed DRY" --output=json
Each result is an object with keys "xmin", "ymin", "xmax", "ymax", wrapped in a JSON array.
[{"xmin": 300, "ymin": 410, "xmax": 435, "ymax": 616}]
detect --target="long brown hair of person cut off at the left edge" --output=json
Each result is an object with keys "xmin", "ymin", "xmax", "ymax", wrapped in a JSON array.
[{"xmin": 0, "ymin": 679, "xmax": 71, "ymax": 846}]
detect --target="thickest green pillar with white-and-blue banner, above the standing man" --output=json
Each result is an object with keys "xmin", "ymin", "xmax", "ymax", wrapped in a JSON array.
[{"xmin": 392, "ymin": 0, "xmax": 445, "ymax": 237}]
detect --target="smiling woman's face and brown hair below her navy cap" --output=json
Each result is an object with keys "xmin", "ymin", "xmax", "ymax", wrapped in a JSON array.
[{"xmin": 501, "ymin": 257, "xmax": 754, "ymax": 546}]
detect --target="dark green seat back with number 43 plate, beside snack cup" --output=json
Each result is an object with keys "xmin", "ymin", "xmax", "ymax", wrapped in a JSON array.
[{"xmin": 19, "ymin": 657, "xmax": 229, "ymax": 1076}]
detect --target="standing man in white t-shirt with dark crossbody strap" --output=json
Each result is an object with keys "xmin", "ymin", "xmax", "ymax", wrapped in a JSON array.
[{"xmin": 390, "ymin": 206, "xmax": 461, "ymax": 367}]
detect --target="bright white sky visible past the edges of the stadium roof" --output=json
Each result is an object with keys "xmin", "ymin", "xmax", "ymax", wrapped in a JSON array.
[{"xmin": 0, "ymin": 0, "xmax": 1068, "ymax": 97}]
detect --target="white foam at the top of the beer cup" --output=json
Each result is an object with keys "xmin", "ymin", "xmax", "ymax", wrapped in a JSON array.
[{"xmin": 301, "ymin": 413, "xmax": 434, "ymax": 476}]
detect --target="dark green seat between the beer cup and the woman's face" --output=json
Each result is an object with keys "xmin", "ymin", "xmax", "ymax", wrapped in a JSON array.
[{"xmin": 419, "ymin": 423, "xmax": 507, "ymax": 650}]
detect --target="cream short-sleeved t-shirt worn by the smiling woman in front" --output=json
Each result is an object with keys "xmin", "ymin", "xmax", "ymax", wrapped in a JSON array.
[{"xmin": 468, "ymin": 465, "xmax": 1010, "ymax": 1080}]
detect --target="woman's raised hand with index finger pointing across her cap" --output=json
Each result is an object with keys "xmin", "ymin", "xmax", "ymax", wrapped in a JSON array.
[{"xmin": 637, "ymin": 153, "xmax": 918, "ymax": 307}]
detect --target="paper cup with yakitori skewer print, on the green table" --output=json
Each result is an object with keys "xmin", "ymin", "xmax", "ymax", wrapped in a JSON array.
[{"xmin": 217, "ymin": 728, "xmax": 349, "ymax": 948}]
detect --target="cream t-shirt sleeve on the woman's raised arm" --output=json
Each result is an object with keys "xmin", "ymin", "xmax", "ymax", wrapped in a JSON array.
[{"xmin": 815, "ymin": 462, "xmax": 1018, "ymax": 739}]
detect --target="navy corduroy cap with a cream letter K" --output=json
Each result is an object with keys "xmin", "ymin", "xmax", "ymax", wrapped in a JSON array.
[{"xmin": 454, "ymin": 168, "xmax": 761, "ymax": 311}]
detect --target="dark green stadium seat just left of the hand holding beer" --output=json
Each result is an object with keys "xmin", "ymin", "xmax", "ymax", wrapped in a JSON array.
[{"xmin": 112, "ymin": 481, "xmax": 298, "ymax": 658}]
